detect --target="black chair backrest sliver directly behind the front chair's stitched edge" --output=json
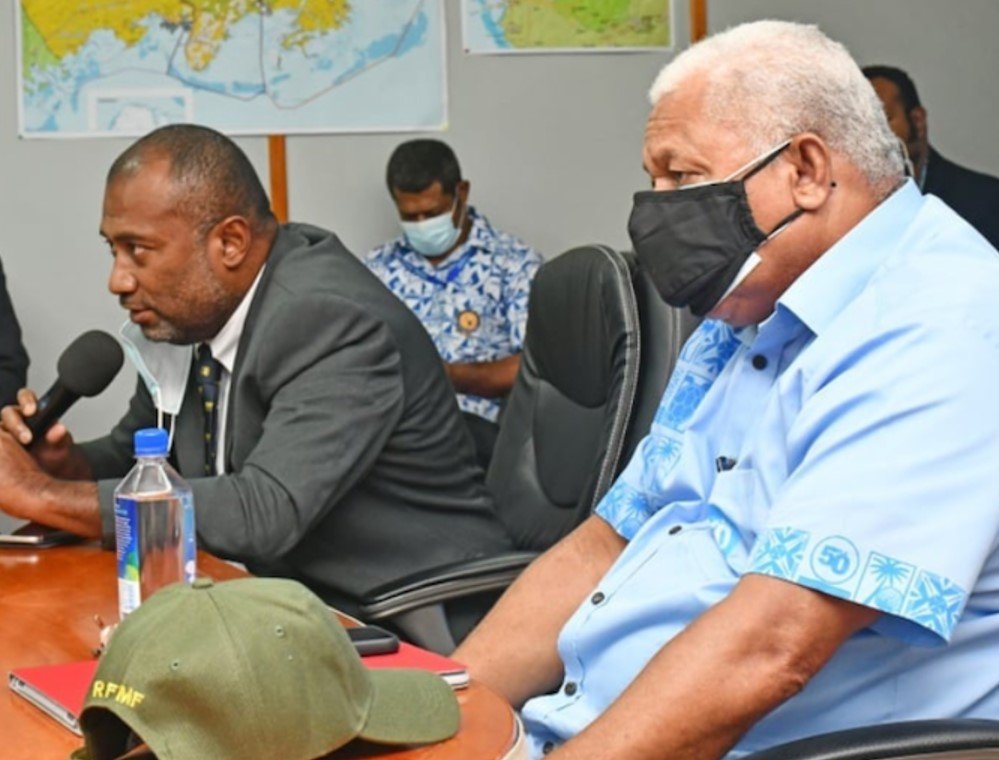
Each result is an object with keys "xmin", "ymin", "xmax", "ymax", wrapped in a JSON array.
[{"xmin": 615, "ymin": 253, "xmax": 701, "ymax": 466}]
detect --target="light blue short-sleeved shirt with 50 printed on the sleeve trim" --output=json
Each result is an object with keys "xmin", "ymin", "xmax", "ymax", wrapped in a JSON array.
[{"xmin": 523, "ymin": 181, "xmax": 999, "ymax": 757}]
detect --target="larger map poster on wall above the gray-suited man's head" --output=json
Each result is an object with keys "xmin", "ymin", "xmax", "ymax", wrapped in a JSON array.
[{"xmin": 15, "ymin": 0, "xmax": 447, "ymax": 138}]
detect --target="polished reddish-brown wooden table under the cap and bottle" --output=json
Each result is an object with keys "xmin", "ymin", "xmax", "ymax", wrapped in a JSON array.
[{"xmin": 0, "ymin": 545, "xmax": 517, "ymax": 760}]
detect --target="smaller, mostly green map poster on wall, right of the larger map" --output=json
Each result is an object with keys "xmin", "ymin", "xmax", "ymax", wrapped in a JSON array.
[{"xmin": 461, "ymin": 0, "xmax": 673, "ymax": 53}]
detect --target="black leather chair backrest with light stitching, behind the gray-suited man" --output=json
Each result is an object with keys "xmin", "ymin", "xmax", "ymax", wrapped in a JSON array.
[{"xmin": 486, "ymin": 246, "xmax": 639, "ymax": 550}]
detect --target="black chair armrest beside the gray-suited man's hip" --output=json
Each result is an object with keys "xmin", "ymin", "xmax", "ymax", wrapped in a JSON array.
[{"xmin": 360, "ymin": 552, "xmax": 538, "ymax": 620}]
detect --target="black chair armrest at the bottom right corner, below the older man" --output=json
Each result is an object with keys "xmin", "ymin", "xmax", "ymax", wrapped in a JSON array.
[{"xmin": 746, "ymin": 719, "xmax": 999, "ymax": 760}]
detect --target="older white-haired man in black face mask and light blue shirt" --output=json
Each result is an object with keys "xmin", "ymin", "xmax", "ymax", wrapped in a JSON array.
[{"xmin": 455, "ymin": 21, "xmax": 999, "ymax": 759}]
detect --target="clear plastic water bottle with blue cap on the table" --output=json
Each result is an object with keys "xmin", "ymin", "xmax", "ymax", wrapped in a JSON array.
[{"xmin": 114, "ymin": 428, "xmax": 197, "ymax": 619}]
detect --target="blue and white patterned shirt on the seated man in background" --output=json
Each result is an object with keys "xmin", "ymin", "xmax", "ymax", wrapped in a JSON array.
[{"xmin": 365, "ymin": 206, "xmax": 541, "ymax": 422}]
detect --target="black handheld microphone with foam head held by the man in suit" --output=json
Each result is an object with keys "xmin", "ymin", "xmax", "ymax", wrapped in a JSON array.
[{"xmin": 24, "ymin": 330, "xmax": 125, "ymax": 440}]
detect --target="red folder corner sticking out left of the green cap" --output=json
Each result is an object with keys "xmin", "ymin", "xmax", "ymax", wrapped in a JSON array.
[{"xmin": 7, "ymin": 660, "xmax": 97, "ymax": 736}]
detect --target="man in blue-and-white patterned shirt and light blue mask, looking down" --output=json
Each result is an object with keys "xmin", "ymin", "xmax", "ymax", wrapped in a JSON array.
[{"xmin": 365, "ymin": 140, "xmax": 541, "ymax": 460}]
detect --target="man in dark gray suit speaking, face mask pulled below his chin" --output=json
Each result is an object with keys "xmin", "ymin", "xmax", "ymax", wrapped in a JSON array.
[{"xmin": 0, "ymin": 125, "xmax": 508, "ymax": 607}]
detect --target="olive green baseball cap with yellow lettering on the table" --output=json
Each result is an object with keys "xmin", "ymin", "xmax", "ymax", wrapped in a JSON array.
[{"xmin": 73, "ymin": 578, "xmax": 460, "ymax": 760}]
